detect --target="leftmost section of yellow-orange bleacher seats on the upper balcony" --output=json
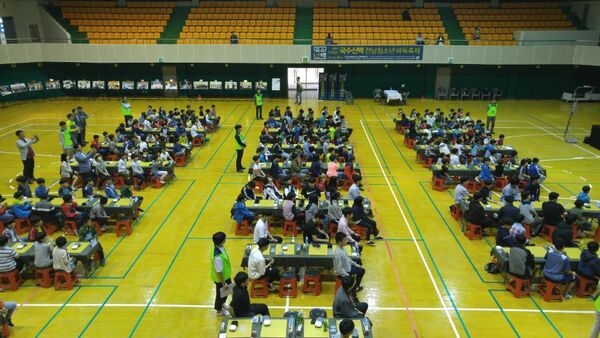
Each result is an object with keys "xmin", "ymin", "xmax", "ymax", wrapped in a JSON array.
[{"xmin": 56, "ymin": 1, "xmax": 175, "ymax": 44}]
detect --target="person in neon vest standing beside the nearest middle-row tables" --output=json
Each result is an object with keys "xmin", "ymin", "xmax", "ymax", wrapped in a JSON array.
[{"xmin": 210, "ymin": 231, "xmax": 232, "ymax": 316}]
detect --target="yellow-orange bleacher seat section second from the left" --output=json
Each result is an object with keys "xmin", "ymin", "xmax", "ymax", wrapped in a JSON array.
[{"xmin": 177, "ymin": 1, "xmax": 296, "ymax": 45}]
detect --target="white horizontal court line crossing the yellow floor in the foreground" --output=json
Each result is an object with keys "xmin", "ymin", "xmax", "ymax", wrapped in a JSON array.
[{"xmin": 19, "ymin": 303, "xmax": 595, "ymax": 315}]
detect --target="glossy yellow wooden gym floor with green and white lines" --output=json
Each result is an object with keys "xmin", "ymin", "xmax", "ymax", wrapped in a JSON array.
[{"xmin": 0, "ymin": 95, "xmax": 600, "ymax": 338}]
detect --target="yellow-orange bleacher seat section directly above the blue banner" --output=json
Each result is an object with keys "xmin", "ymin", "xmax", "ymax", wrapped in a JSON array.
[{"xmin": 313, "ymin": 1, "xmax": 448, "ymax": 45}]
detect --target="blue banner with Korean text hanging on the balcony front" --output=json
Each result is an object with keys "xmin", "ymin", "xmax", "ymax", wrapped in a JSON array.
[{"xmin": 311, "ymin": 45, "xmax": 423, "ymax": 61}]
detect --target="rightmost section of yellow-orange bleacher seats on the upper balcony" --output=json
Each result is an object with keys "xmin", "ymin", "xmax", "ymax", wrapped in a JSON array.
[{"xmin": 453, "ymin": 2, "xmax": 576, "ymax": 46}]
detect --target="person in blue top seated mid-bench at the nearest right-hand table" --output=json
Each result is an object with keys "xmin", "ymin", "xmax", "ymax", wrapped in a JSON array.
[{"xmin": 544, "ymin": 238, "xmax": 576, "ymax": 299}]
